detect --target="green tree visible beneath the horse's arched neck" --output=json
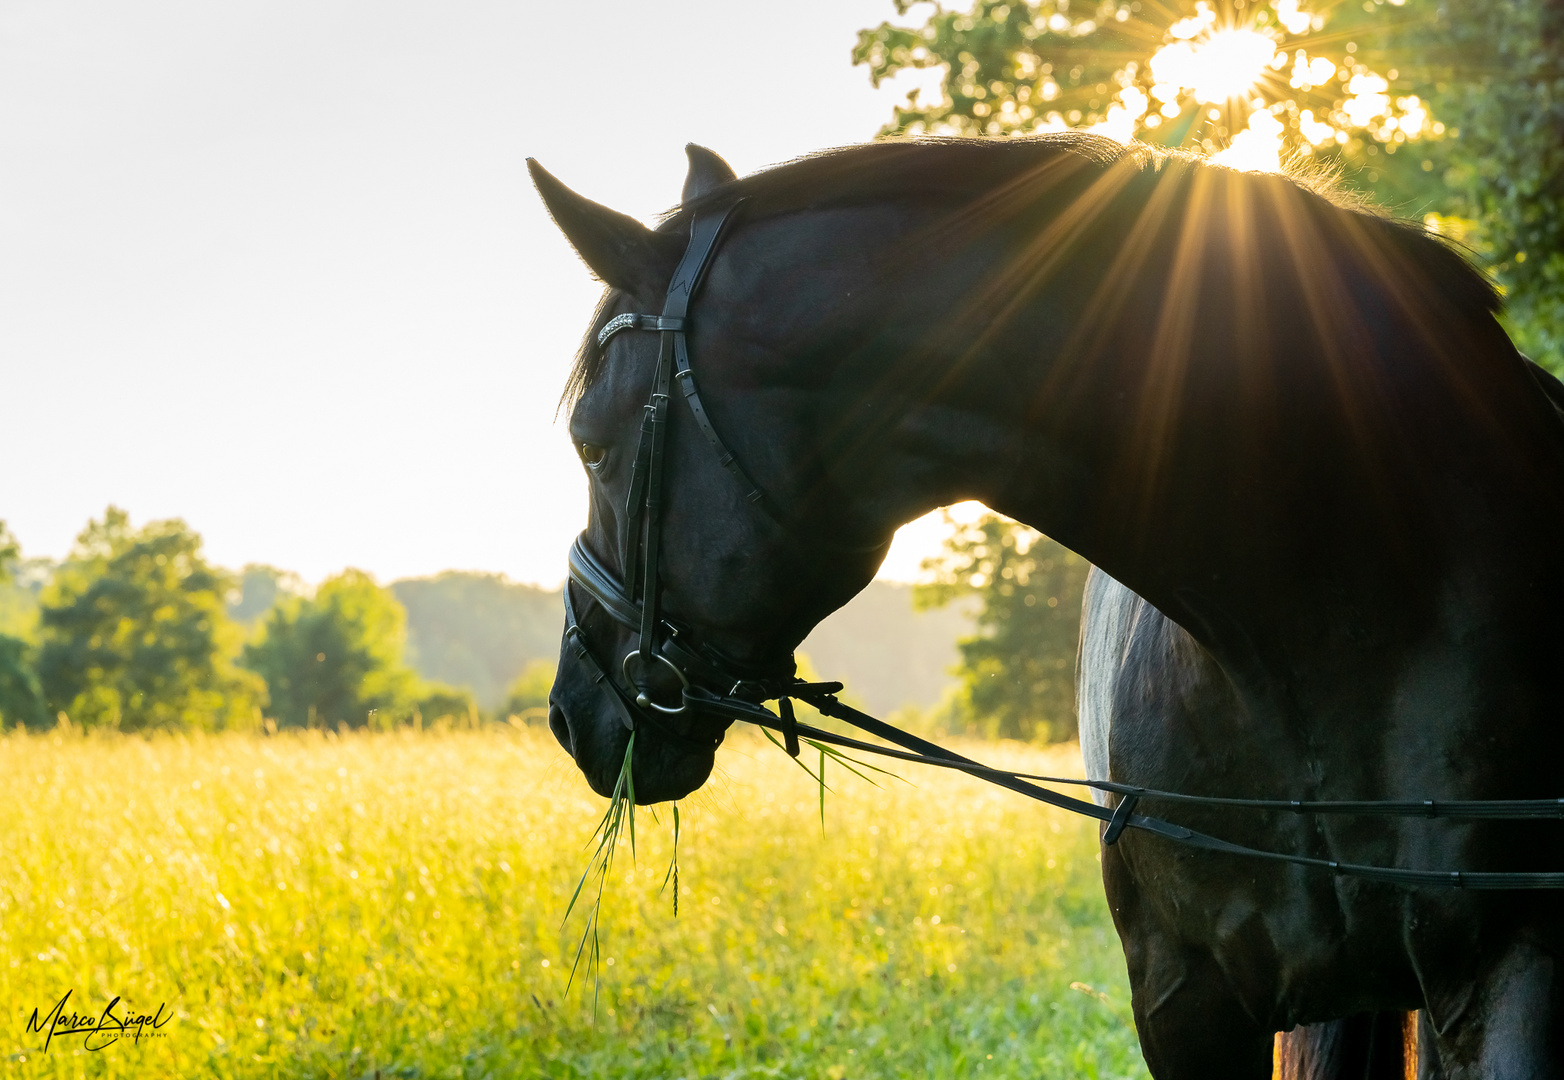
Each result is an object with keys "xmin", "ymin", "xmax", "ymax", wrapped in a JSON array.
[{"xmin": 917, "ymin": 514, "xmax": 1090, "ymax": 742}]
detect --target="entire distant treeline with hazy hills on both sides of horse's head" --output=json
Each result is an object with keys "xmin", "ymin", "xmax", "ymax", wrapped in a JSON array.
[{"xmin": 0, "ymin": 506, "xmax": 971, "ymax": 730}]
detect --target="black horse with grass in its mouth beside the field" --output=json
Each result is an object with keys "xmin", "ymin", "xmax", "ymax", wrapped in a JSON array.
[{"xmin": 533, "ymin": 136, "xmax": 1564, "ymax": 1080}]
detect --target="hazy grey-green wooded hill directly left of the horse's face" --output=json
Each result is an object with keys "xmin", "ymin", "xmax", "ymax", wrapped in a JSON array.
[{"xmin": 391, "ymin": 570, "xmax": 563, "ymax": 708}]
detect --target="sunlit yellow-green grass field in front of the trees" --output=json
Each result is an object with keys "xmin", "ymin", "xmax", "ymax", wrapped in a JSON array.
[{"xmin": 0, "ymin": 728, "xmax": 1145, "ymax": 1080}]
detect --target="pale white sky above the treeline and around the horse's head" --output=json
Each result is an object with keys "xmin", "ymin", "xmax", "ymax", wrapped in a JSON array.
[{"xmin": 0, "ymin": 0, "xmax": 943, "ymax": 586}]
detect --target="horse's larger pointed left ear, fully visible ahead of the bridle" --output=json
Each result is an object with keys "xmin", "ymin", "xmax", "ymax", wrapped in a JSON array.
[{"xmin": 527, "ymin": 158, "xmax": 683, "ymax": 300}]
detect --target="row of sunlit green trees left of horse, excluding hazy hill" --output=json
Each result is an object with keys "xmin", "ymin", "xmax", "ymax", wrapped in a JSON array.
[{"xmin": 0, "ymin": 506, "xmax": 519, "ymax": 731}]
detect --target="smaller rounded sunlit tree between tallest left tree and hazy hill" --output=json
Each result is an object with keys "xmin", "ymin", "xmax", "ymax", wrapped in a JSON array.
[{"xmin": 244, "ymin": 569, "xmax": 419, "ymax": 727}]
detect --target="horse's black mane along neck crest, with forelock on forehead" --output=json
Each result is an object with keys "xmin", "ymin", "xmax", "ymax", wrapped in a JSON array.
[{"xmin": 561, "ymin": 131, "xmax": 1501, "ymax": 408}]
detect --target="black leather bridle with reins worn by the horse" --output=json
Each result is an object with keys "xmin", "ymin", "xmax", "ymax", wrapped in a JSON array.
[{"xmin": 565, "ymin": 200, "xmax": 1564, "ymax": 889}]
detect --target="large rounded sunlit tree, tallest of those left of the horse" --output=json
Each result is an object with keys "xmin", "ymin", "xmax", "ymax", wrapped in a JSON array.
[{"xmin": 38, "ymin": 506, "xmax": 264, "ymax": 731}]
